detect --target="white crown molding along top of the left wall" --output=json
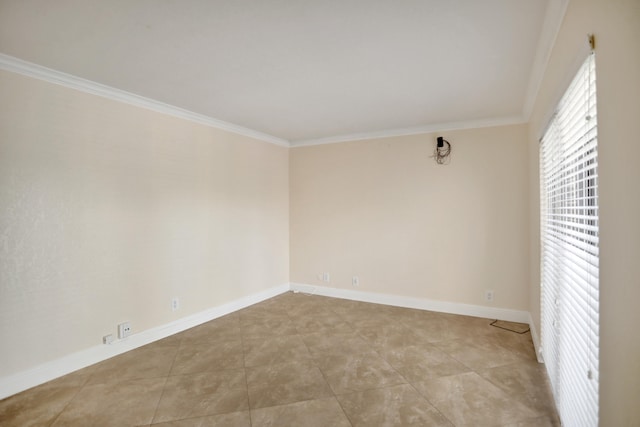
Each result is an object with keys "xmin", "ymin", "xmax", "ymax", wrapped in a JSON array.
[{"xmin": 0, "ymin": 53, "xmax": 290, "ymax": 147}]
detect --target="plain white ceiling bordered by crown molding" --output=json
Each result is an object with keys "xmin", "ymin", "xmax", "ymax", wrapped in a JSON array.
[{"xmin": 0, "ymin": 0, "xmax": 560, "ymax": 145}]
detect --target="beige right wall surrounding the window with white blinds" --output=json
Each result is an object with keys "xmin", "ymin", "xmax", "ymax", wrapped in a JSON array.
[{"xmin": 530, "ymin": 0, "xmax": 640, "ymax": 427}]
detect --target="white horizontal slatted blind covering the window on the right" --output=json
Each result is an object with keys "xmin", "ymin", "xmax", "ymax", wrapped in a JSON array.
[{"xmin": 540, "ymin": 53, "xmax": 599, "ymax": 427}]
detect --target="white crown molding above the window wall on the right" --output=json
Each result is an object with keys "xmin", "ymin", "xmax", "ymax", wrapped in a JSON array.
[{"xmin": 522, "ymin": 0, "xmax": 569, "ymax": 121}]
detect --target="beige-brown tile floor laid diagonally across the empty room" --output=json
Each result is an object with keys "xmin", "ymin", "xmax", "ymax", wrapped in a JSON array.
[{"xmin": 0, "ymin": 292, "xmax": 560, "ymax": 427}]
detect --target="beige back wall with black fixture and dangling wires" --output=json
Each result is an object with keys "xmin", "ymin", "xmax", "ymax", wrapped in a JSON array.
[{"xmin": 290, "ymin": 125, "xmax": 529, "ymax": 310}]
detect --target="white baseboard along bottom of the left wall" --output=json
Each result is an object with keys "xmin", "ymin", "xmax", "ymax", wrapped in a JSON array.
[{"xmin": 0, "ymin": 283, "xmax": 291, "ymax": 399}]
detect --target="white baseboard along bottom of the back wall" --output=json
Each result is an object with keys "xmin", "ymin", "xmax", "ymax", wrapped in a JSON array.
[{"xmin": 291, "ymin": 283, "xmax": 531, "ymax": 323}]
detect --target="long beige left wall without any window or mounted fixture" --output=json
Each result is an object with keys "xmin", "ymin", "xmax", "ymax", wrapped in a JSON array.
[{"xmin": 0, "ymin": 71, "xmax": 289, "ymax": 377}]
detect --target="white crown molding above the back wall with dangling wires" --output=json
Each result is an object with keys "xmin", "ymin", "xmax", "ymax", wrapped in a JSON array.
[{"xmin": 291, "ymin": 116, "xmax": 526, "ymax": 147}]
